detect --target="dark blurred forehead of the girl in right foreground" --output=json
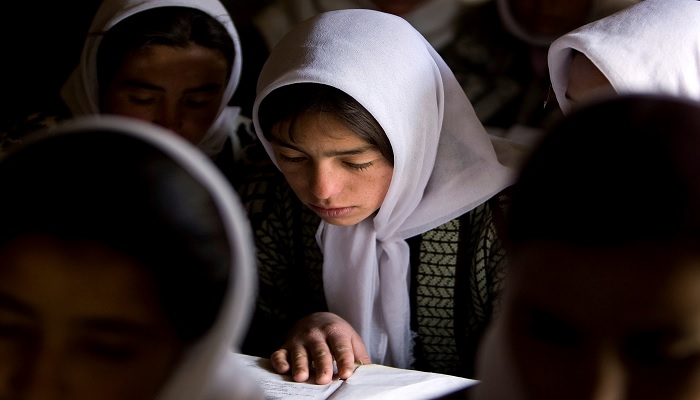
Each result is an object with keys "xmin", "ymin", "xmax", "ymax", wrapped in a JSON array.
[{"xmin": 509, "ymin": 243, "xmax": 700, "ymax": 329}]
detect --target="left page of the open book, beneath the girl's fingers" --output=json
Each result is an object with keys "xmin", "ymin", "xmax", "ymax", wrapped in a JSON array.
[{"xmin": 236, "ymin": 354, "xmax": 343, "ymax": 400}]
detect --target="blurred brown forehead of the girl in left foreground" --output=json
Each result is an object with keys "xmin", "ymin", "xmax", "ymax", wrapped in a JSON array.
[{"xmin": 0, "ymin": 236, "xmax": 161, "ymax": 321}]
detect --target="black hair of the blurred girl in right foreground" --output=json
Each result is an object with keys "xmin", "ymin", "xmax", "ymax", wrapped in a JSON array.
[{"xmin": 507, "ymin": 95, "xmax": 700, "ymax": 247}]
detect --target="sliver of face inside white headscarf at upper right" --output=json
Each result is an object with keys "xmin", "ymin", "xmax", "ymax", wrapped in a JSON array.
[{"xmin": 565, "ymin": 52, "xmax": 616, "ymax": 111}]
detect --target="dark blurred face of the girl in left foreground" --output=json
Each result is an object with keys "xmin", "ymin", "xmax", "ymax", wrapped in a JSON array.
[{"xmin": 0, "ymin": 237, "xmax": 182, "ymax": 400}]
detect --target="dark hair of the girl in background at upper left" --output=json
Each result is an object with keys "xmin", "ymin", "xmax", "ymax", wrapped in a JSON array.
[{"xmin": 97, "ymin": 7, "xmax": 236, "ymax": 107}]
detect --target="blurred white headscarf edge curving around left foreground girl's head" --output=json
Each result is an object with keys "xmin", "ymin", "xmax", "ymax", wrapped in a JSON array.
[{"xmin": 47, "ymin": 115, "xmax": 262, "ymax": 400}]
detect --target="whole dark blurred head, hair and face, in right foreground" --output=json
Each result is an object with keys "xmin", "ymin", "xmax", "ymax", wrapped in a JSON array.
[{"xmin": 477, "ymin": 95, "xmax": 700, "ymax": 400}]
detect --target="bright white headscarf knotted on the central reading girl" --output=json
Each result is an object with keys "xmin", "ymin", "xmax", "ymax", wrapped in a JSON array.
[{"xmin": 253, "ymin": 9, "xmax": 512, "ymax": 367}]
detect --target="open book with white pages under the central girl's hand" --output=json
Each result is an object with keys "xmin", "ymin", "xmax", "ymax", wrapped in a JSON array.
[{"xmin": 236, "ymin": 354, "xmax": 478, "ymax": 400}]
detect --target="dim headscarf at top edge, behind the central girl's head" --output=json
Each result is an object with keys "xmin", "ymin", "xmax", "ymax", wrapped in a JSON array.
[{"xmin": 255, "ymin": 0, "xmax": 463, "ymax": 50}]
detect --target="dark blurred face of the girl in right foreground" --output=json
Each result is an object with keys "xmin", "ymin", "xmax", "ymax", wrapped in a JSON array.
[{"xmin": 494, "ymin": 244, "xmax": 700, "ymax": 400}]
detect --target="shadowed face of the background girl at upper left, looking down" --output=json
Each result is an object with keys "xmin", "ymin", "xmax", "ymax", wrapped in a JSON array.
[{"xmin": 102, "ymin": 45, "xmax": 229, "ymax": 145}]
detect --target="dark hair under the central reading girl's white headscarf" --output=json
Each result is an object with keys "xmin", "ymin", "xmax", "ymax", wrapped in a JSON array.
[{"xmin": 258, "ymin": 83, "xmax": 394, "ymax": 164}]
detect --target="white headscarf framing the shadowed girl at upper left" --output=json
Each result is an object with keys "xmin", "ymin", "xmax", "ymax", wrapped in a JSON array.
[{"xmin": 61, "ymin": 0, "xmax": 242, "ymax": 156}]
